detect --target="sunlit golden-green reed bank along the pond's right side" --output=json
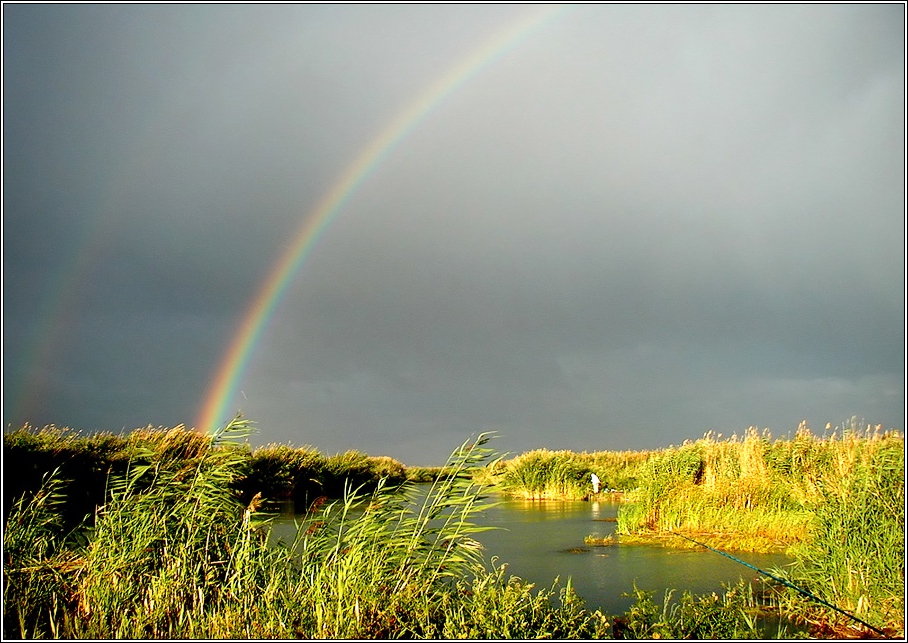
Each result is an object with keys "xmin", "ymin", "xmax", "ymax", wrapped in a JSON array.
[{"xmin": 484, "ymin": 420, "xmax": 905, "ymax": 632}]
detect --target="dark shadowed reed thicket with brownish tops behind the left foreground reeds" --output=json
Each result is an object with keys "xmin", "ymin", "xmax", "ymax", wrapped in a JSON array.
[{"xmin": 3, "ymin": 425, "xmax": 441, "ymax": 527}]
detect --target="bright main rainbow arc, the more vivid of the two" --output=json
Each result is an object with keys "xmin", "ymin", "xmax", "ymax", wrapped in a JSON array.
[{"xmin": 196, "ymin": 6, "xmax": 566, "ymax": 433}]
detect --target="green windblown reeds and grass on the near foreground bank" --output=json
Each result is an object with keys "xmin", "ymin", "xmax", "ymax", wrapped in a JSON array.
[{"xmin": 3, "ymin": 422, "xmax": 816, "ymax": 639}]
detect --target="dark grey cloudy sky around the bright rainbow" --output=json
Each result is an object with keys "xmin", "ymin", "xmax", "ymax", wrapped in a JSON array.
[{"xmin": 3, "ymin": 4, "xmax": 905, "ymax": 464}]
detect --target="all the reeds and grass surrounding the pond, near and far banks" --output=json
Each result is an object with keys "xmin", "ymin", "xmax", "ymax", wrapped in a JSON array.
[{"xmin": 3, "ymin": 418, "xmax": 905, "ymax": 638}]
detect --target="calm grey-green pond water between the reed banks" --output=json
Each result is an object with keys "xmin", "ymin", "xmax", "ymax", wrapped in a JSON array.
[{"xmin": 272, "ymin": 495, "xmax": 791, "ymax": 614}]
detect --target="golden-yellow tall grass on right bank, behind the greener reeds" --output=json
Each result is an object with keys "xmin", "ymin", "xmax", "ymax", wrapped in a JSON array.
[{"xmin": 618, "ymin": 423, "xmax": 904, "ymax": 550}]
